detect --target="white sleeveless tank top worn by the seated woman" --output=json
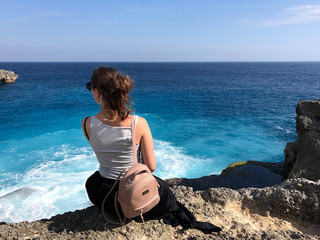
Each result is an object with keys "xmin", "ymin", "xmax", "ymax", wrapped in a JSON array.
[{"xmin": 89, "ymin": 115, "xmax": 140, "ymax": 179}]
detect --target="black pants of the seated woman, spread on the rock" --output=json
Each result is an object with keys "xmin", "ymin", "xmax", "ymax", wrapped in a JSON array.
[{"xmin": 86, "ymin": 171, "xmax": 221, "ymax": 233}]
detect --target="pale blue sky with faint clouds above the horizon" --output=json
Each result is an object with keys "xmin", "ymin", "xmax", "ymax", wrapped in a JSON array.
[{"xmin": 0, "ymin": 0, "xmax": 320, "ymax": 62}]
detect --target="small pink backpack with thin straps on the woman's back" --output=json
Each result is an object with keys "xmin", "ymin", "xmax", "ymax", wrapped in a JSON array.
[{"xmin": 102, "ymin": 116, "xmax": 160, "ymax": 225}]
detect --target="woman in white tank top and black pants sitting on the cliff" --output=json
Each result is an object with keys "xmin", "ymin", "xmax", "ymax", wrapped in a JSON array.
[{"xmin": 82, "ymin": 67, "xmax": 221, "ymax": 232}]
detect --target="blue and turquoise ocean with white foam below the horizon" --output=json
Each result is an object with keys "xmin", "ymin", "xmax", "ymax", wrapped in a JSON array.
[{"xmin": 0, "ymin": 62, "xmax": 320, "ymax": 222}]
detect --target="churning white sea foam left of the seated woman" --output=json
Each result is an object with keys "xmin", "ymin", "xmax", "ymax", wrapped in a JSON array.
[{"xmin": 0, "ymin": 145, "xmax": 98, "ymax": 222}]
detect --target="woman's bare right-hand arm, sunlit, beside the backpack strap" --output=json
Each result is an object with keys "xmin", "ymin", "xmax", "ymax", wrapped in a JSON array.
[{"xmin": 137, "ymin": 117, "xmax": 156, "ymax": 172}]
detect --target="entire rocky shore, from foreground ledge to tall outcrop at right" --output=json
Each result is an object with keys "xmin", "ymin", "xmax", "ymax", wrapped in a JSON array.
[{"xmin": 0, "ymin": 100, "xmax": 320, "ymax": 240}]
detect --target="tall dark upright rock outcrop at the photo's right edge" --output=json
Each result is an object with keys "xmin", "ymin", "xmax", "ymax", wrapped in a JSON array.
[{"xmin": 285, "ymin": 100, "xmax": 320, "ymax": 181}]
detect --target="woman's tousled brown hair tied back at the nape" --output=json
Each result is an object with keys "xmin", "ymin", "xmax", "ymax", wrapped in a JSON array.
[{"xmin": 91, "ymin": 67, "xmax": 133, "ymax": 121}]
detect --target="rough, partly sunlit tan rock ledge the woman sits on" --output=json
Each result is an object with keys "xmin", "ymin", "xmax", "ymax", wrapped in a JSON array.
[{"xmin": 0, "ymin": 178, "xmax": 320, "ymax": 240}]
